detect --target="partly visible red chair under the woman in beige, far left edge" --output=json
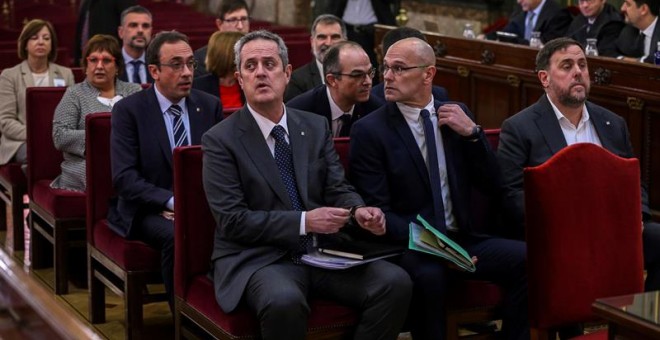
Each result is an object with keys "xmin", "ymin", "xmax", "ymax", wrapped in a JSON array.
[{"xmin": 0, "ymin": 163, "xmax": 27, "ymax": 254}]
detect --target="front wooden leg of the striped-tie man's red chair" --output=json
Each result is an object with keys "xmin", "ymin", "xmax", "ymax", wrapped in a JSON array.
[{"xmin": 124, "ymin": 273, "xmax": 145, "ymax": 340}]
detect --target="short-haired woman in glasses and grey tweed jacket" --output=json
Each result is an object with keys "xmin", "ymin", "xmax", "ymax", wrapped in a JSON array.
[{"xmin": 51, "ymin": 34, "xmax": 142, "ymax": 191}]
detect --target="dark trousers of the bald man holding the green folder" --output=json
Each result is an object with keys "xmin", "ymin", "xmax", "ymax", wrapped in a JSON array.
[{"xmin": 400, "ymin": 236, "xmax": 530, "ymax": 340}]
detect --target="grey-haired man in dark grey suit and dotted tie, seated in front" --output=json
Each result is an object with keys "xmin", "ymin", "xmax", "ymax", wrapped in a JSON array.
[{"xmin": 202, "ymin": 31, "xmax": 412, "ymax": 339}]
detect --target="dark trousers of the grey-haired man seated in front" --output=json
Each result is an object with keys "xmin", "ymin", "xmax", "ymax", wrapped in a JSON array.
[{"xmin": 244, "ymin": 257, "xmax": 412, "ymax": 340}]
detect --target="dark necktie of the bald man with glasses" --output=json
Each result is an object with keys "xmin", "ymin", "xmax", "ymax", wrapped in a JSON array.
[{"xmin": 419, "ymin": 110, "xmax": 447, "ymax": 234}]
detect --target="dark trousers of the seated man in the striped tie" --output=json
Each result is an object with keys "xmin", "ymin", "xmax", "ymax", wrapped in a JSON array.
[{"xmin": 135, "ymin": 214, "xmax": 174, "ymax": 311}]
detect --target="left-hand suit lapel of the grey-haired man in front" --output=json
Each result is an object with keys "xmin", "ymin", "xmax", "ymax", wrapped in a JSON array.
[{"xmin": 234, "ymin": 106, "xmax": 290, "ymax": 208}]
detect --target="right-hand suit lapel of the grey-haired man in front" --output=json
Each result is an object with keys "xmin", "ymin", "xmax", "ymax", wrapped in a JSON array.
[{"xmin": 287, "ymin": 109, "xmax": 311, "ymax": 207}]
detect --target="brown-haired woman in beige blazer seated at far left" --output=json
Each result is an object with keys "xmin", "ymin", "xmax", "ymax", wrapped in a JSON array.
[{"xmin": 0, "ymin": 19, "xmax": 75, "ymax": 165}]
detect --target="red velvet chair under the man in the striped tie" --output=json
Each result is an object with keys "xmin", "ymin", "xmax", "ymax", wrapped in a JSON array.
[{"xmin": 85, "ymin": 113, "xmax": 167, "ymax": 339}]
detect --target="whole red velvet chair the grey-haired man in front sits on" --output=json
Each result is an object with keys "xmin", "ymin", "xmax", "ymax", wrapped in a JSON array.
[{"xmin": 174, "ymin": 146, "xmax": 357, "ymax": 339}]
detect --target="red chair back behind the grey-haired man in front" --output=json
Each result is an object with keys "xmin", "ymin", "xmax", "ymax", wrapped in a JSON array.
[{"xmin": 174, "ymin": 146, "xmax": 211, "ymax": 300}]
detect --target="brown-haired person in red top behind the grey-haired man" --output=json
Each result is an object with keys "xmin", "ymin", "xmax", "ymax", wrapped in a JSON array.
[{"xmin": 193, "ymin": 32, "xmax": 245, "ymax": 108}]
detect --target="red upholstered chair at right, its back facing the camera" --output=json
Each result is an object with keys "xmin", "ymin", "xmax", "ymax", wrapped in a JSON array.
[{"xmin": 524, "ymin": 143, "xmax": 644, "ymax": 339}]
